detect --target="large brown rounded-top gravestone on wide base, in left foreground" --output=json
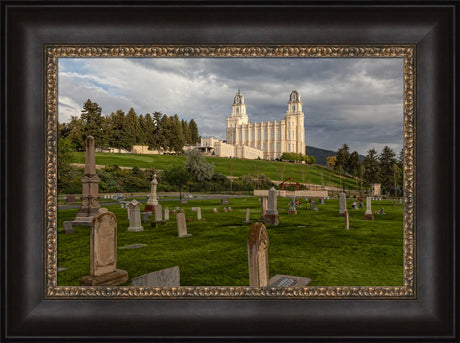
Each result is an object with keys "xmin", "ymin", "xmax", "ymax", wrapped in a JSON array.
[{"xmin": 79, "ymin": 212, "xmax": 128, "ymax": 286}]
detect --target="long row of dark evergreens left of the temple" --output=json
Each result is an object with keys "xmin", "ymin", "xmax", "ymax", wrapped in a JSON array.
[{"xmin": 59, "ymin": 99, "xmax": 199, "ymax": 151}]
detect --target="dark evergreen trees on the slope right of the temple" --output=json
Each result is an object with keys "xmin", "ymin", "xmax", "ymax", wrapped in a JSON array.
[{"xmin": 327, "ymin": 144, "xmax": 404, "ymax": 194}]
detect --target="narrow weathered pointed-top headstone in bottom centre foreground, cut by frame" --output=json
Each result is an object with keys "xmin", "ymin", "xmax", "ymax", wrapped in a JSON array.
[{"xmin": 248, "ymin": 222, "xmax": 269, "ymax": 287}]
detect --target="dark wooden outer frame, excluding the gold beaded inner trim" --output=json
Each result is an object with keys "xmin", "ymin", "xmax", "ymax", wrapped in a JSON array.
[{"xmin": 1, "ymin": 1, "xmax": 458, "ymax": 342}]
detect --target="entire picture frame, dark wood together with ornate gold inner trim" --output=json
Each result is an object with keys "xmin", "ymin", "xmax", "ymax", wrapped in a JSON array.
[{"xmin": 0, "ymin": 1, "xmax": 458, "ymax": 341}]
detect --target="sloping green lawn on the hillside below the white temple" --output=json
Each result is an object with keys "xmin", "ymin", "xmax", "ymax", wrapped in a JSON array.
[{"xmin": 72, "ymin": 152, "xmax": 359, "ymax": 189}]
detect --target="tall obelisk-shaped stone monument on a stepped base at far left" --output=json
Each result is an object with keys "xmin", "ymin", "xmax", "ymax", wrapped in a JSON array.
[{"xmin": 74, "ymin": 136, "xmax": 101, "ymax": 225}]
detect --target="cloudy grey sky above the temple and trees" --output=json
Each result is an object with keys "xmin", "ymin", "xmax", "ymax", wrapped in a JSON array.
[{"xmin": 58, "ymin": 58, "xmax": 403, "ymax": 154}]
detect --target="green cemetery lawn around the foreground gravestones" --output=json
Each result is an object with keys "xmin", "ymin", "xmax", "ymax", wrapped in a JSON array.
[{"xmin": 57, "ymin": 197, "xmax": 403, "ymax": 286}]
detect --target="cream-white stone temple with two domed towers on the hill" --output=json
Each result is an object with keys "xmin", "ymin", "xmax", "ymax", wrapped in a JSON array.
[{"xmin": 196, "ymin": 90, "xmax": 305, "ymax": 160}]
